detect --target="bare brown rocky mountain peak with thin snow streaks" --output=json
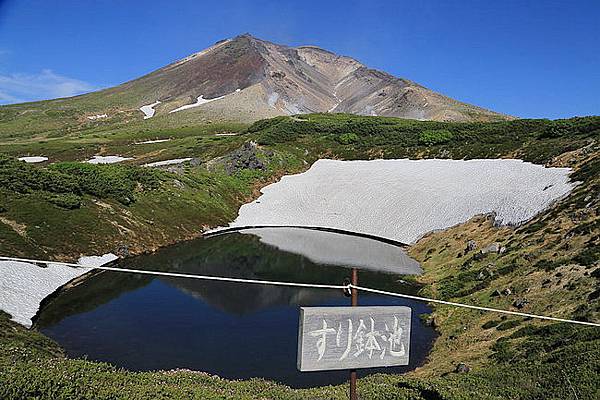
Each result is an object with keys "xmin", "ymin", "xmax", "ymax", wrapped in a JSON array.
[{"xmin": 9, "ymin": 34, "xmax": 511, "ymax": 123}]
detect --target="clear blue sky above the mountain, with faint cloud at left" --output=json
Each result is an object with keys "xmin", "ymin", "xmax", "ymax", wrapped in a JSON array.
[{"xmin": 0, "ymin": 0, "xmax": 600, "ymax": 118}]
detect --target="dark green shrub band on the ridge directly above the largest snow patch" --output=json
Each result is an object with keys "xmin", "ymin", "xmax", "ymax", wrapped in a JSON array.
[{"xmin": 247, "ymin": 114, "xmax": 600, "ymax": 163}]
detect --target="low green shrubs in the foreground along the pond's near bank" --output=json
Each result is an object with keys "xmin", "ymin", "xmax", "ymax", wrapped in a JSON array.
[{"xmin": 0, "ymin": 315, "xmax": 600, "ymax": 400}]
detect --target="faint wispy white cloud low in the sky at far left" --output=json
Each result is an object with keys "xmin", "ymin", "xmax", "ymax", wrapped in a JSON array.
[{"xmin": 0, "ymin": 69, "xmax": 97, "ymax": 104}]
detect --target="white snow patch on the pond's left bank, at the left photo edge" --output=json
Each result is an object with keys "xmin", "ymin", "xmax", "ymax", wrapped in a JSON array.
[{"xmin": 0, "ymin": 253, "xmax": 118, "ymax": 327}]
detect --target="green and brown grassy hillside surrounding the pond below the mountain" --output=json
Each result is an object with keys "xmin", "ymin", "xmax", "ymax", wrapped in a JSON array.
[{"xmin": 0, "ymin": 114, "xmax": 600, "ymax": 400}]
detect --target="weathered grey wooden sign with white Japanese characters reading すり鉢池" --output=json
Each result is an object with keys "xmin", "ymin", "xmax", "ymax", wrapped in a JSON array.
[{"xmin": 298, "ymin": 306, "xmax": 411, "ymax": 371}]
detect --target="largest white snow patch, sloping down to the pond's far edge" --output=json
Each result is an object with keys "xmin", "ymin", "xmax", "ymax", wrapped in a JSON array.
[{"xmin": 223, "ymin": 159, "xmax": 575, "ymax": 244}]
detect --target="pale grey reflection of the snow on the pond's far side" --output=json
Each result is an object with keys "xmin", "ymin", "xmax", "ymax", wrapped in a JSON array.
[{"xmin": 240, "ymin": 228, "xmax": 422, "ymax": 275}]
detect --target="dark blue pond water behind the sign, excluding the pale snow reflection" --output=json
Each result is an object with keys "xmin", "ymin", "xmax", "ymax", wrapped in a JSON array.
[{"xmin": 36, "ymin": 233, "xmax": 435, "ymax": 387}]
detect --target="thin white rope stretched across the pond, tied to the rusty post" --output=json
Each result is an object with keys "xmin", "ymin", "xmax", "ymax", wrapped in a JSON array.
[{"xmin": 0, "ymin": 256, "xmax": 600, "ymax": 327}]
